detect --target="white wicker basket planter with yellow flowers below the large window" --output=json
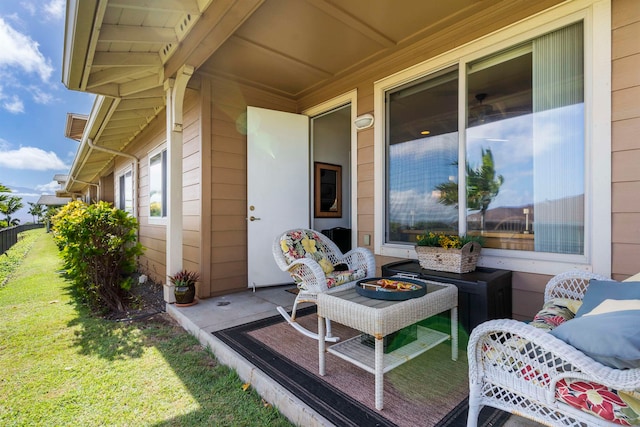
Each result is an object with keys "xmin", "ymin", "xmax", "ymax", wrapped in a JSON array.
[{"xmin": 415, "ymin": 232, "xmax": 482, "ymax": 273}]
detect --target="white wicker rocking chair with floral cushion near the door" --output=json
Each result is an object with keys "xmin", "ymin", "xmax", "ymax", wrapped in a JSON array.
[{"xmin": 272, "ymin": 229, "xmax": 376, "ymax": 342}]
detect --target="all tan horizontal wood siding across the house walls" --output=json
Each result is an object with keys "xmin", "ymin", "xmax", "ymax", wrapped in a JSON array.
[{"xmin": 100, "ymin": 0, "xmax": 640, "ymax": 319}]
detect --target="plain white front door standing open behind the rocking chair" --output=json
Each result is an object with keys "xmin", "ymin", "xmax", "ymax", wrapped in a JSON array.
[{"xmin": 247, "ymin": 107, "xmax": 310, "ymax": 287}]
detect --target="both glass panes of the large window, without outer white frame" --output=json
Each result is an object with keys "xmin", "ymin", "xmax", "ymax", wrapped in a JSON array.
[{"xmin": 385, "ymin": 23, "xmax": 585, "ymax": 255}]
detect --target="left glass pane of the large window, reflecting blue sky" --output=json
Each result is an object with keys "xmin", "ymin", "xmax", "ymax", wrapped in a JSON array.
[{"xmin": 386, "ymin": 68, "xmax": 458, "ymax": 243}]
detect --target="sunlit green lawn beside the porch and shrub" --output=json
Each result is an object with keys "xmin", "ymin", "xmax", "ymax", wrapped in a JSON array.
[{"xmin": 0, "ymin": 230, "xmax": 291, "ymax": 426}]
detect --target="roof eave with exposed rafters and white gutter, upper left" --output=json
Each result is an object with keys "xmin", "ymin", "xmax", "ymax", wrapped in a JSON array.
[{"xmin": 62, "ymin": 0, "xmax": 255, "ymax": 193}]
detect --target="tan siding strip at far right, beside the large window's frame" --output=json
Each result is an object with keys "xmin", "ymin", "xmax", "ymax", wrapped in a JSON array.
[{"xmin": 611, "ymin": 0, "xmax": 640, "ymax": 280}]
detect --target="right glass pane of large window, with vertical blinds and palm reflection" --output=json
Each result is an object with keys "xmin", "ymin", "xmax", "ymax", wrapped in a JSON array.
[{"xmin": 466, "ymin": 24, "xmax": 584, "ymax": 254}]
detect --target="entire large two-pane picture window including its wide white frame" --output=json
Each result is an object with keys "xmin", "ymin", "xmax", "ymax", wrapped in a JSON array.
[{"xmin": 374, "ymin": 0, "xmax": 612, "ymax": 274}]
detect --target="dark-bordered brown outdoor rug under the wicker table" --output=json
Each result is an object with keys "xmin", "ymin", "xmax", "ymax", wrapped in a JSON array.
[{"xmin": 213, "ymin": 307, "xmax": 509, "ymax": 427}]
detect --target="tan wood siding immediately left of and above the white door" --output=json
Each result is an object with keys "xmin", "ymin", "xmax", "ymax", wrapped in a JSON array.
[{"xmin": 205, "ymin": 75, "xmax": 296, "ymax": 296}]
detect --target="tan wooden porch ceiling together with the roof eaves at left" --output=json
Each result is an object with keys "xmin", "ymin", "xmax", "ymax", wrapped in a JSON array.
[{"xmin": 63, "ymin": 0, "xmax": 549, "ymax": 192}]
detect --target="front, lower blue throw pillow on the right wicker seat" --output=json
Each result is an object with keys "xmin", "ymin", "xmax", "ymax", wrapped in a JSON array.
[{"xmin": 549, "ymin": 310, "xmax": 640, "ymax": 369}]
